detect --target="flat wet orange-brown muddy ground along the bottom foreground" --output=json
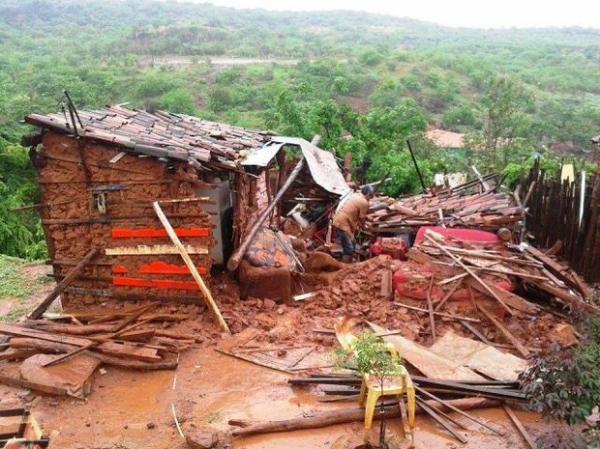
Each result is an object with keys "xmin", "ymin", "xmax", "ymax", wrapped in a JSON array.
[{"xmin": 0, "ymin": 348, "xmax": 548, "ymax": 449}]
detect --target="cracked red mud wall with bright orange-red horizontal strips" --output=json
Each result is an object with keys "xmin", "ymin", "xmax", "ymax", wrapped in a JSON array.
[{"xmin": 38, "ymin": 131, "xmax": 214, "ymax": 309}]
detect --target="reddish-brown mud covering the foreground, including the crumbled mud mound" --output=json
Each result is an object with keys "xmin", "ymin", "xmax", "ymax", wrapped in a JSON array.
[{"xmin": 0, "ymin": 258, "xmax": 556, "ymax": 449}]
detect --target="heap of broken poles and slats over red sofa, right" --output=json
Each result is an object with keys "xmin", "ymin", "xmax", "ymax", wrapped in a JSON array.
[{"xmin": 395, "ymin": 230, "xmax": 600, "ymax": 358}]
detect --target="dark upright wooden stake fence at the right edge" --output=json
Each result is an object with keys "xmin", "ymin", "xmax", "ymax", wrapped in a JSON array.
[{"xmin": 520, "ymin": 159, "xmax": 600, "ymax": 282}]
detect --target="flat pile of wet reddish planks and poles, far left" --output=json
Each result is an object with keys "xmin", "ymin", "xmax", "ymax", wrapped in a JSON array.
[{"xmin": 0, "ymin": 303, "xmax": 194, "ymax": 396}]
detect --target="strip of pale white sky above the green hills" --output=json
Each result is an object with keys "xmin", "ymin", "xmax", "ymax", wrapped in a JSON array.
[{"xmin": 188, "ymin": 0, "xmax": 600, "ymax": 28}]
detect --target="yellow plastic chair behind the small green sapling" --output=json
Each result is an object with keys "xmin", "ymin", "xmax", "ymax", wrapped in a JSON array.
[{"xmin": 334, "ymin": 317, "xmax": 416, "ymax": 439}]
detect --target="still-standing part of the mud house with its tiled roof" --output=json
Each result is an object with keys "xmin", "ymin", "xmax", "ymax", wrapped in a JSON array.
[{"xmin": 26, "ymin": 106, "xmax": 349, "ymax": 308}]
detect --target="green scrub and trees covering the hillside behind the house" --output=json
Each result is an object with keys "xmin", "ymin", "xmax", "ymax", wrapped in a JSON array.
[{"xmin": 0, "ymin": 0, "xmax": 600, "ymax": 257}]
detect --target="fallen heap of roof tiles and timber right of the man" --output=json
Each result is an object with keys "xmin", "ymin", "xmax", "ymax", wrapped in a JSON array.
[{"xmin": 367, "ymin": 175, "xmax": 523, "ymax": 233}]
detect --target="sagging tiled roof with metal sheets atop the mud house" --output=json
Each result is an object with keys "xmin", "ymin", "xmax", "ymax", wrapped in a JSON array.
[{"xmin": 25, "ymin": 105, "xmax": 350, "ymax": 195}]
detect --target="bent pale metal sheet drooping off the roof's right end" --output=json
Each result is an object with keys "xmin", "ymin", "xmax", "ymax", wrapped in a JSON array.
[{"xmin": 271, "ymin": 136, "xmax": 350, "ymax": 195}]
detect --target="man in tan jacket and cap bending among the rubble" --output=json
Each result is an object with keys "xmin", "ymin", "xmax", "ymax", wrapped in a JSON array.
[{"xmin": 332, "ymin": 185, "xmax": 374, "ymax": 262}]
